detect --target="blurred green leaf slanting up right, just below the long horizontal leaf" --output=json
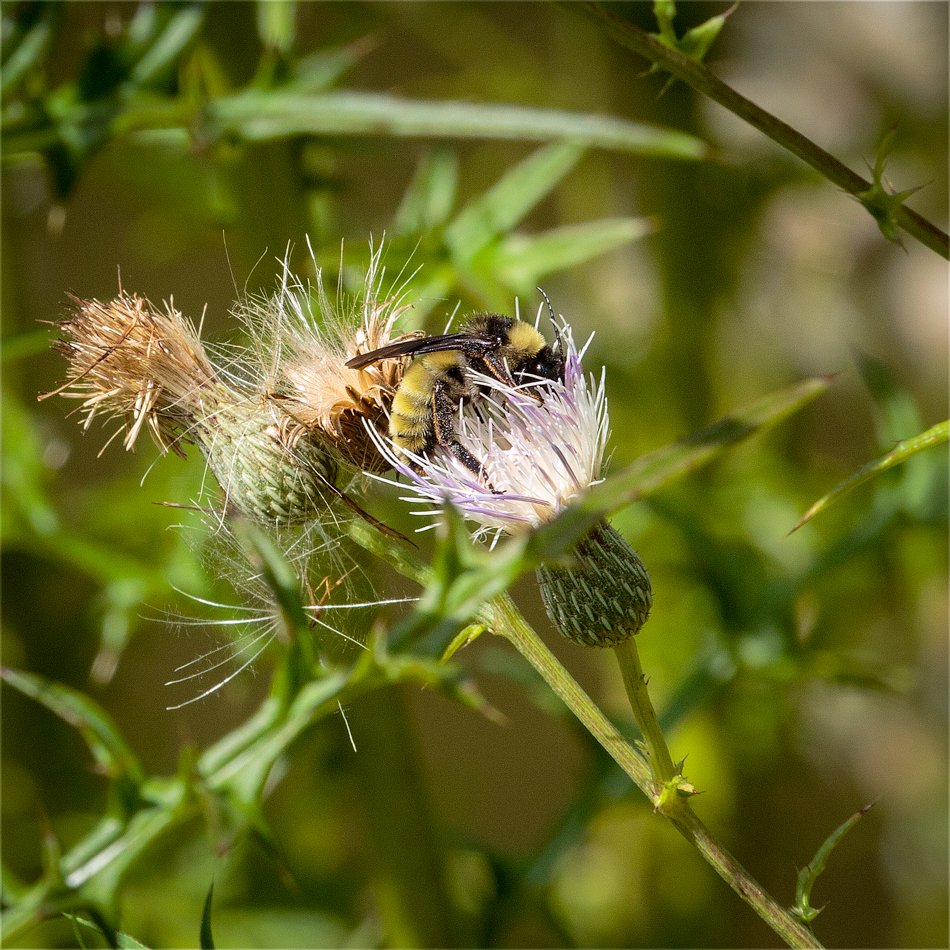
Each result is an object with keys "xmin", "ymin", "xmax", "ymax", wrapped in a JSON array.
[{"xmin": 445, "ymin": 142, "xmax": 584, "ymax": 259}]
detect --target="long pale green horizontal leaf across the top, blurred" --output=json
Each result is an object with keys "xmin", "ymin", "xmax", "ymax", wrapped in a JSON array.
[{"xmin": 204, "ymin": 90, "xmax": 708, "ymax": 161}]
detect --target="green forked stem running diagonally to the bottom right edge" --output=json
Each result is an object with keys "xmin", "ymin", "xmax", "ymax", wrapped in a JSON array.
[{"xmin": 480, "ymin": 595, "xmax": 821, "ymax": 947}]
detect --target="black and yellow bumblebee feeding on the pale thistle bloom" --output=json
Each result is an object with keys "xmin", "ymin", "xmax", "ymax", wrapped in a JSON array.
[{"xmin": 346, "ymin": 313, "xmax": 564, "ymax": 478}]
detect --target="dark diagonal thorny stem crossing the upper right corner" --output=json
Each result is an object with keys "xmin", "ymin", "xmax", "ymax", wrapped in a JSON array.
[{"xmin": 565, "ymin": 0, "xmax": 950, "ymax": 260}]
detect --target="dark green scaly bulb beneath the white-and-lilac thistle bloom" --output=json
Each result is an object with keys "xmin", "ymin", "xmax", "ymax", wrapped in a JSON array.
[{"xmin": 537, "ymin": 522, "xmax": 653, "ymax": 647}]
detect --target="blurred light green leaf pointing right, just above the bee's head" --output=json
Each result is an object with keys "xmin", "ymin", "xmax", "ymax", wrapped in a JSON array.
[{"xmin": 491, "ymin": 218, "xmax": 654, "ymax": 289}]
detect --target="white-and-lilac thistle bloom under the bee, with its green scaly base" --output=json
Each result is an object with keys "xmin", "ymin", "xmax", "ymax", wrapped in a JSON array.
[{"xmin": 369, "ymin": 311, "xmax": 652, "ymax": 646}]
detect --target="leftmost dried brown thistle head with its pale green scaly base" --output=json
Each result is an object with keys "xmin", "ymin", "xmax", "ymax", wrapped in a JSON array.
[{"xmin": 40, "ymin": 292, "xmax": 336, "ymax": 524}]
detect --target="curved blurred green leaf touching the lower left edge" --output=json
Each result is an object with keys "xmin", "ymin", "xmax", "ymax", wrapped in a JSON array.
[{"xmin": 0, "ymin": 668, "xmax": 144, "ymax": 785}]
